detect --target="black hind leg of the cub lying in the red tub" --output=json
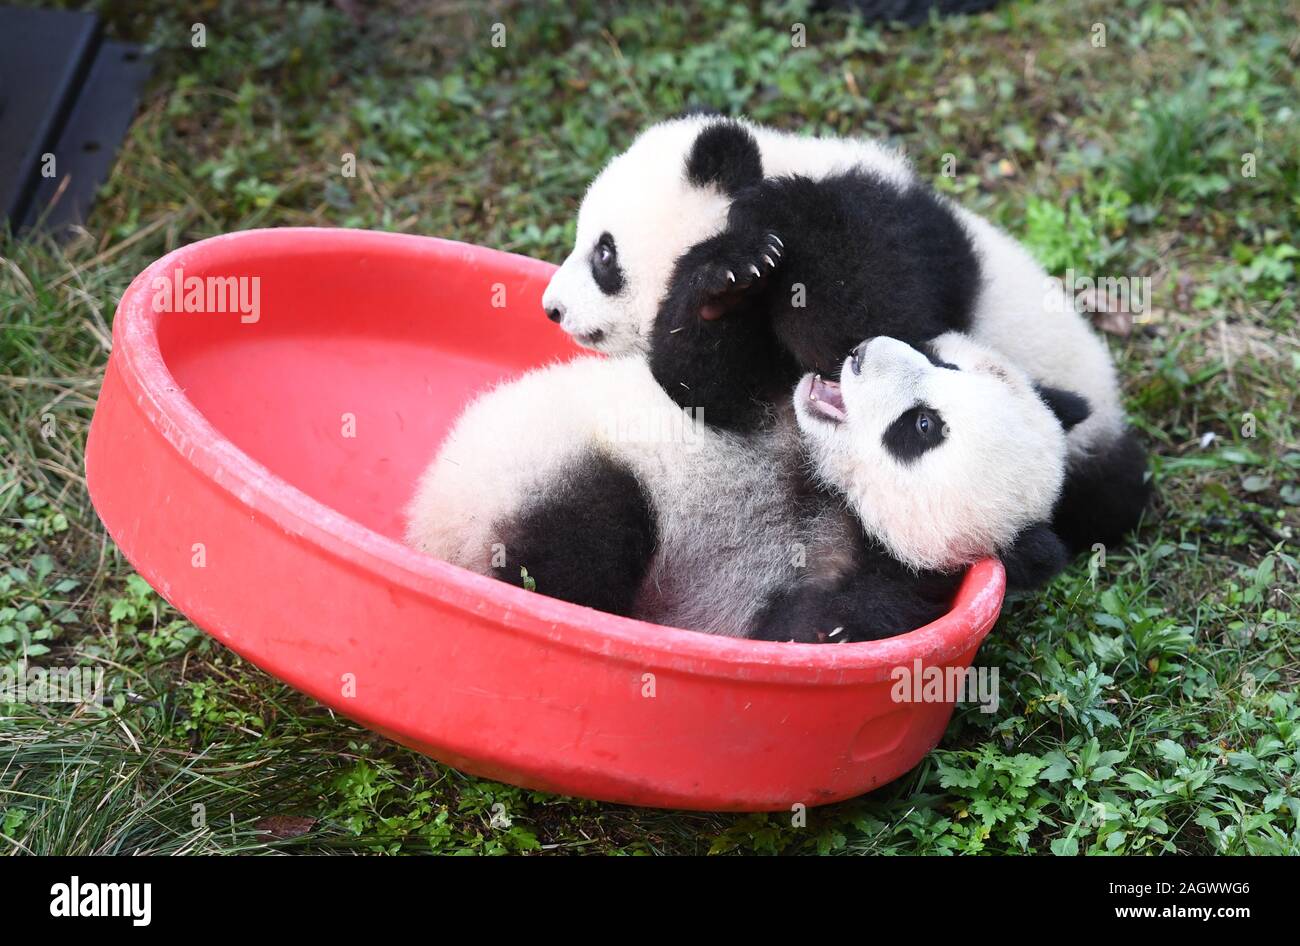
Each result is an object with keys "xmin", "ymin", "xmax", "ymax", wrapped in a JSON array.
[{"xmin": 494, "ymin": 451, "xmax": 658, "ymax": 615}]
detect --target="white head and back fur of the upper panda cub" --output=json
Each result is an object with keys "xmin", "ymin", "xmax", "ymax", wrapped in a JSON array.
[{"xmin": 543, "ymin": 116, "xmax": 1123, "ymax": 456}]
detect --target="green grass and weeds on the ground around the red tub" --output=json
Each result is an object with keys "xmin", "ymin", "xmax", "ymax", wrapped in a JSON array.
[{"xmin": 0, "ymin": 0, "xmax": 1300, "ymax": 855}]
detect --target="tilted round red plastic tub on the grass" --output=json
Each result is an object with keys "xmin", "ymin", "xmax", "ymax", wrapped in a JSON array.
[{"xmin": 86, "ymin": 230, "xmax": 1004, "ymax": 810}]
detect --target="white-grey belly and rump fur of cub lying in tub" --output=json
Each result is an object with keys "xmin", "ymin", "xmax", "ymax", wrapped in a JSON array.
[{"xmin": 407, "ymin": 357, "xmax": 811, "ymax": 635}]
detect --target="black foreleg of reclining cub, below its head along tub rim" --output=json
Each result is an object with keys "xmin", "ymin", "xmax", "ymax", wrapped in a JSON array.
[{"xmin": 751, "ymin": 528, "xmax": 962, "ymax": 643}]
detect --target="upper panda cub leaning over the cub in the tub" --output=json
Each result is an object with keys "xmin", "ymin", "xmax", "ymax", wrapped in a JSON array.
[{"xmin": 543, "ymin": 114, "xmax": 1148, "ymax": 550}]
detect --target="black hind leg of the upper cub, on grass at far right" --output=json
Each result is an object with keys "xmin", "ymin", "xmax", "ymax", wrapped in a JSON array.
[{"xmin": 1052, "ymin": 430, "xmax": 1151, "ymax": 554}]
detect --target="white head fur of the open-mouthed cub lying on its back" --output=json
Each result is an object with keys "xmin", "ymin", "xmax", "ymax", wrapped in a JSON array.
[{"xmin": 794, "ymin": 333, "xmax": 1066, "ymax": 570}]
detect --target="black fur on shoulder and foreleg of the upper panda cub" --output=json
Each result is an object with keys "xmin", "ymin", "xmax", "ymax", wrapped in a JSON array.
[{"xmin": 651, "ymin": 166, "xmax": 980, "ymax": 429}]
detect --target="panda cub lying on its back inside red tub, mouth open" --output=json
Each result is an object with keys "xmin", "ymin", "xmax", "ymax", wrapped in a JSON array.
[{"xmin": 407, "ymin": 334, "xmax": 1087, "ymax": 642}]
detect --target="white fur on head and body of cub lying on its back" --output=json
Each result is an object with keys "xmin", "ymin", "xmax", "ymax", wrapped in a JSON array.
[{"xmin": 407, "ymin": 334, "xmax": 1065, "ymax": 635}]
